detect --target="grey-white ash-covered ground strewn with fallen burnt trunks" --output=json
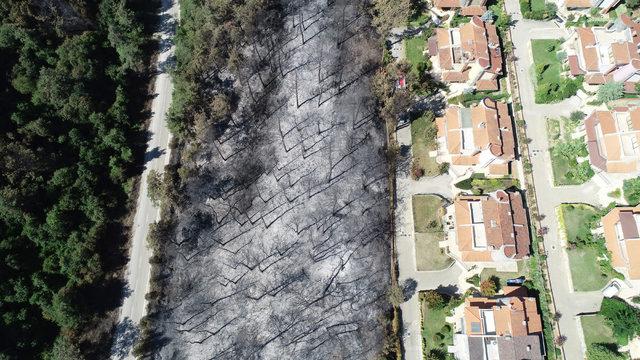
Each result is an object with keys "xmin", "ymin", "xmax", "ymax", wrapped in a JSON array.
[{"xmin": 154, "ymin": 1, "xmax": 390, "ymax": 359}]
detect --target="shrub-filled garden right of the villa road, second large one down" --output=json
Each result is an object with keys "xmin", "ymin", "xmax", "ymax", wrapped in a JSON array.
[{"xmin": 547, "ymin": 111, "xmax": 595, "ymax": 186}]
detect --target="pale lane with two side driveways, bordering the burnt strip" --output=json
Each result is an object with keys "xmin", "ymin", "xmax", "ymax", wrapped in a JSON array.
[{"xmin": 395, "ymin": 127, "xmax": 464, "ymax": 360}]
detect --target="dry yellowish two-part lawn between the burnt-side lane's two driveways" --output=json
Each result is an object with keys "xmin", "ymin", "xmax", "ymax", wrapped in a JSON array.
[{"xmin": 411, "ymin": 195, "xmax": 452, "ymax": 271}]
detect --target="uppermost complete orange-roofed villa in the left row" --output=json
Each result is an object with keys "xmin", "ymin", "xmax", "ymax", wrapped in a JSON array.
[{"xmin": 429, "ymin": 16, "xmax": 503, "ymax": 90}]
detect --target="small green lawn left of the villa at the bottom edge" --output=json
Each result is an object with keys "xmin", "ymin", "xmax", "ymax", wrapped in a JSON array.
[{"xmin": 420, "ymin": 301, "xmax": 453, "ymax": 354}]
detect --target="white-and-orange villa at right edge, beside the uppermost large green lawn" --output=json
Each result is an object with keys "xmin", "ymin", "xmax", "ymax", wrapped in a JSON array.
[{"xmin": 567, "ymin": 17, "xmax": 640, "ymax": 88}]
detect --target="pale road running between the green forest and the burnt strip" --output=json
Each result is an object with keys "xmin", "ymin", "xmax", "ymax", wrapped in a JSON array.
[{"xmin": 112, "ymin": 0, "xmax": 179, "ymax": 359}]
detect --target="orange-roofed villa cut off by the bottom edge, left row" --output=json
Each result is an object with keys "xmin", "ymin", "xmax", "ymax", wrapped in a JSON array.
[{"xmin": 449, "ymin": 286, "xmax": 545, "ymax": 360}]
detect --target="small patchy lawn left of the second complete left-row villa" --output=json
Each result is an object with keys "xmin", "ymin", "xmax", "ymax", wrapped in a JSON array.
[{"xmin": 411, "ymin": 112, "xmax": 440, "ymax": 176}]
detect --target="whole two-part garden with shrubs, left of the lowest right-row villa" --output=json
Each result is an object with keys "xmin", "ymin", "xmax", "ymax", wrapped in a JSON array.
[{"xmin": 558, "ymin": 204, "xmax": 622, "ymax": 291}]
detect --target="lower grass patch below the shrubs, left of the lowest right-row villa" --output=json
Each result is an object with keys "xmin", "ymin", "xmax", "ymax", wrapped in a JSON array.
[{"xmin": 567, "ymin": 247, "xmax": 612, "ymax": 291}]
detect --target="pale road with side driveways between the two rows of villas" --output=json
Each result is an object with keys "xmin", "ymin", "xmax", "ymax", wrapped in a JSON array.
[{"xmin": 506, "ymin": 0, "xmax": 606, "ymax": 360}]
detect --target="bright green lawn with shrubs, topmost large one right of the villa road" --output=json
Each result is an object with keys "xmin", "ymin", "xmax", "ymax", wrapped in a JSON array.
[{"xmin": 531, "ymin": 39, "xmax": 583, "ymax": 104}]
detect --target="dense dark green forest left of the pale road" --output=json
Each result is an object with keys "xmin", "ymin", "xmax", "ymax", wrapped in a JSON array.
[{"xmin": 0, "ymin": 0, "xmax": 154, "ymax": 359}]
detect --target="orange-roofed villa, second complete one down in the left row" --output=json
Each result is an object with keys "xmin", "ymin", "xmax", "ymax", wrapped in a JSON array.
[{"xmin": 436, "ymin": 98, "xmax": 515, "ymax": 176}]
